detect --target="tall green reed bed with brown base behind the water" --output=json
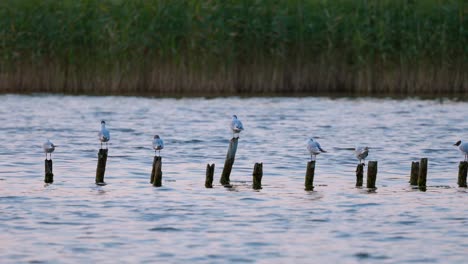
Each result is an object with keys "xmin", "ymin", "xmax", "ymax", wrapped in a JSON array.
[{"xmin": 0, "ymin": 0, "xmax": 468, "ymax": 95}]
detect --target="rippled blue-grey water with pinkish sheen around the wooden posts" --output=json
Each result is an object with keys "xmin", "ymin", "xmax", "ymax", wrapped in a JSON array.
[{"xmin": 0, "ymin": 95, "xmax": 468, "ymax": 263}]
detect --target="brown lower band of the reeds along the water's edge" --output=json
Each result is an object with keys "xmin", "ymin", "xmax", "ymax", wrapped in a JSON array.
[{"xmin": 0, "ymin": 61, "xmax": 468, "ymax": 96}]
